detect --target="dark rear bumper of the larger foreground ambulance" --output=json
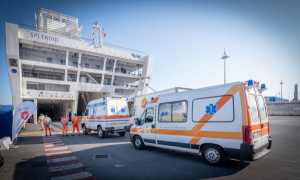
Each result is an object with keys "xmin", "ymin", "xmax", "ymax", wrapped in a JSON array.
[{"xmin": 240, "ymin": 137, "xmax": 272, "ymax": 161}]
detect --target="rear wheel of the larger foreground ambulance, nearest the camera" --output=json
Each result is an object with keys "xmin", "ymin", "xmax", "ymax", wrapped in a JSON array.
[{"xmin": 201, "ymin": 144, "xmax": 226, "ymax": 166}]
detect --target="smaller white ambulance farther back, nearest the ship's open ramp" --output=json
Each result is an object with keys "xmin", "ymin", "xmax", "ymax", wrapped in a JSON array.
[{"xmin": 81, "ymin": 97, "xmax": 130, "ymax": 138}]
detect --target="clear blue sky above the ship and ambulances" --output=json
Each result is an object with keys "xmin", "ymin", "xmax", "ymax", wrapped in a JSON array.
[{"xmin": 0, "ymin": 0, "xmax": 300, "ymax": 104}]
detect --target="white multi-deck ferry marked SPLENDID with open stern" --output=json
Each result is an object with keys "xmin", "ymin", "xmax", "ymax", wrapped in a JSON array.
[{"xmin": 5, "ymin": 9, "xmax": 154, "ymax": 121}]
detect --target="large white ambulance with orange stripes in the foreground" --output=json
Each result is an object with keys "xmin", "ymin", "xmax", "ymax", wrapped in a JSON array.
[{"xmin": 130, "ymin": 80, "xmax": 272, "ymax": 165}]
